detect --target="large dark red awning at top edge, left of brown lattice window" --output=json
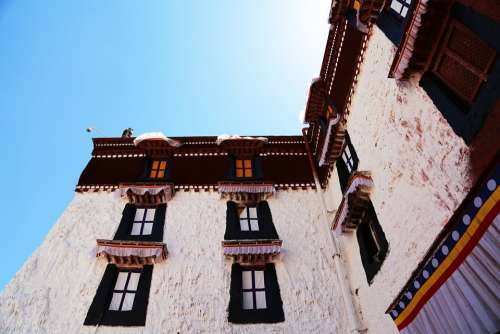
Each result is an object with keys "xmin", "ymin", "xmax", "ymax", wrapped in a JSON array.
[{"xmin": 389, "ymin": 0, "xmax": 453, "ymax": 80}]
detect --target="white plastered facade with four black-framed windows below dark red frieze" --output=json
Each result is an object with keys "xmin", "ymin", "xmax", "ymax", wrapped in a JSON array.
[{"xmin": 0, "ymin": 190, "xmax": 347, "ymax": 333}]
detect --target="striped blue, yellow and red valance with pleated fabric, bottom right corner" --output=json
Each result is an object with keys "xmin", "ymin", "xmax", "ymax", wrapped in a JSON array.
[{"xmin": 387, "ymin": 162, "xmax": 500, "ymax": 334}]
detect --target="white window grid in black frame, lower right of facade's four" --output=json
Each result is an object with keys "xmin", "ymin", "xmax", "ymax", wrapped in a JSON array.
[{"xmin": 242, "ymin": 270, "xmax": 267, "ymax": 310}]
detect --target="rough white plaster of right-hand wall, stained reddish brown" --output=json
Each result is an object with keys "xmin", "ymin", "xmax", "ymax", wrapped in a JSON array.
[{"xmin": 325, "ymin": 27, "xmax": 471, "ymax": 334}]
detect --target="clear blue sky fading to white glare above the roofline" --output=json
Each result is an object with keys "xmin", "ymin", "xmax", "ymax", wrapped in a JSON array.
[{"xmin": 0, "ymin": 0, "xmax": 331, "ymax": 289}]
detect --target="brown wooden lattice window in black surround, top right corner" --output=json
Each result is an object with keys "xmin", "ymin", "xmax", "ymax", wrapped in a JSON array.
[{"xmin": 432, "ymin": 20, "xmax": 496, "ymax": 103}]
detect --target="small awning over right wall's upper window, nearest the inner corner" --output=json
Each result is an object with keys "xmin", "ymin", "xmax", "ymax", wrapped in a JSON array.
[{"xmin": 319, "ymin": 114, "xmax": 346, "ymax": 167}]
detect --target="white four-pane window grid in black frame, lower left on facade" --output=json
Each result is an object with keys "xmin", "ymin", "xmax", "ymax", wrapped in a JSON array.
[{"xmin": 109, "ymin": 271, "xmax": 141, "ymax": 311}]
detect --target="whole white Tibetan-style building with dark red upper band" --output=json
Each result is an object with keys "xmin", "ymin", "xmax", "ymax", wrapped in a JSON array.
[{"xmin": 0, "ymin": 0, "xmax": 500, "ymax": 334}]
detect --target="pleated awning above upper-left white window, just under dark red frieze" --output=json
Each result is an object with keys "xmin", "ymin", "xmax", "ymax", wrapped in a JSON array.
[{"xmin": 115, "ymin": 182, "xmax": 174, "ymax": 205}]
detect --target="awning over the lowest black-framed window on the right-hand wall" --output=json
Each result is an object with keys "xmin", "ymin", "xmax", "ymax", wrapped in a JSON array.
[{"xmin": 332, "ymin": 172, "xmax": 373, "ymax": 232}]
